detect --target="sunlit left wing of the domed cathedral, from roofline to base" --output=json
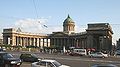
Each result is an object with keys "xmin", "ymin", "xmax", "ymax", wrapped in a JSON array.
[{"xmin": 3, "ymin": 28, "xmax": 50, "ymax": 48}]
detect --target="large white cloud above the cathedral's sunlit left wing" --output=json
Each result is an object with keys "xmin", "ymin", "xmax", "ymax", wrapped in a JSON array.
[{"xmin": 15, "ymin": 17, "xmax": 62, "ymax": 34}]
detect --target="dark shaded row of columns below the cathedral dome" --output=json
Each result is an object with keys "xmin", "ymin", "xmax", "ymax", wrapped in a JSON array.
[{"xmin": 50, "ymin": 37, "xmax": 87, "ymax": 48}]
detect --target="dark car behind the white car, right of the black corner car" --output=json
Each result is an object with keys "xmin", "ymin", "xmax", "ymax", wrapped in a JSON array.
[{"xmin": 20, "ymin": 53, "xmax": 39, "ymax": 62}]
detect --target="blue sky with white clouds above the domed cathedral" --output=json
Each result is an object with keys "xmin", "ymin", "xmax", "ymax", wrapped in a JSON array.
[{"xmin": 0, "ymin": 0, "xmax": 120, "ymax": 42}]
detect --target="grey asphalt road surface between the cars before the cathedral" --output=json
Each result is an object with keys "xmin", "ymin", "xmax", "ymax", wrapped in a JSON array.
[{"xmin": 10, "ymin": 52, "xmax": 120, "ymax": 67}]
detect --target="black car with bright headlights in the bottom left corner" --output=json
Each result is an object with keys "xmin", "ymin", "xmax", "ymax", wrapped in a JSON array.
[{"xmin": 0, "ymin": 52, "xmax": 22, "ymax": 67}]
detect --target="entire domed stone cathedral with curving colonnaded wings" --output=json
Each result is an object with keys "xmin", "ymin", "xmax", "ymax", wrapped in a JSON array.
[{"xmin": 3, "ymin": 15, "xmax": 113, "ymax": 51}]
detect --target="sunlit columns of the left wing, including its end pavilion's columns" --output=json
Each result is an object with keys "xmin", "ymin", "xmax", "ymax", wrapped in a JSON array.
[{"xmin": 3, "ymin": 36, "xmax": 50, "ymax": 48}]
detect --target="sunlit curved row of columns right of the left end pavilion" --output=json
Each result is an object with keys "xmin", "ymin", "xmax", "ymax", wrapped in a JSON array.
[{"xmin": 16, "ymin": 37, "xmax": 50, "ymax": 48}]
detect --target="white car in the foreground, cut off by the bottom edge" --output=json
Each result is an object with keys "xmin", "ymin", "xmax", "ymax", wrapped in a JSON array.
[{"xmin": 31, "ymin": 59, "xmax": 70, "ymax": 67}]
